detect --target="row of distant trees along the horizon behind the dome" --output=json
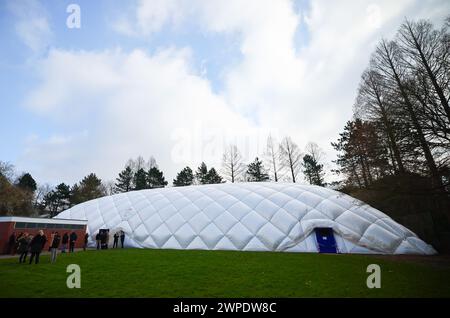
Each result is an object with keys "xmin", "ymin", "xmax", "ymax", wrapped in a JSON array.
[{"xmin": 0, "ymin": 136, "xmax": 325, "ymax": 217}]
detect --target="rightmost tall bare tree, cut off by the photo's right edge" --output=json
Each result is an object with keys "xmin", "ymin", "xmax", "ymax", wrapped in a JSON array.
[{"xmin": 396, "ymin": 20, "xmax": 450, "ymax": 157}]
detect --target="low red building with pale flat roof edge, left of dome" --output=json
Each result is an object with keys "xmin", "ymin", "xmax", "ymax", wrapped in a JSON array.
[{"xmin": 0, "ymin": 216, "xmax": 87, "ymax": 254}]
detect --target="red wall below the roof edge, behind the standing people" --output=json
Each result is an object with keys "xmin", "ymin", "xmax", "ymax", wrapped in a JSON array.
[{"xmin": 0, "ymin": 222, "xmax": 86, "ymax": 254}]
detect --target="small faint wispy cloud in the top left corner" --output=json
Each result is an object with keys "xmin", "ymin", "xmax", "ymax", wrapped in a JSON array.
[{"xmin": 8, "ymin": 0, "xmax": 52, "ymax": 52}]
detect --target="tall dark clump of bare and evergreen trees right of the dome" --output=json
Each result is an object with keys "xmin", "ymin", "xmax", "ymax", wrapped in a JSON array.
[{"xmin": 332, "ymin": 16, "xmax": 450, "ymax": 251}]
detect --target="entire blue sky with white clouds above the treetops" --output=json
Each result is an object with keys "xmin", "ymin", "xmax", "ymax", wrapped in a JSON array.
[{"xmin": 0, "ymin": 0, "xmax": 450, "ymax": 184}]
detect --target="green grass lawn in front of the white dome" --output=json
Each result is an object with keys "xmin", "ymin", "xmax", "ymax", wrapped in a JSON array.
[{"xmin": 0, "ymin": 249, "xmax": 450, "ymax": 297}]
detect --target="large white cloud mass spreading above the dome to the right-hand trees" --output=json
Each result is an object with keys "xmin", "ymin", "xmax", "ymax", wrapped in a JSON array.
[{"xmin": 19, "ymin": 0, "xmax": 450, "ymax": 181}]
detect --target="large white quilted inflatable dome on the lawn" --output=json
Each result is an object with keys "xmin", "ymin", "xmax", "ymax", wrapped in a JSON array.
[{"xmin": 56, "ymin": 182, "xmax": 436, "ymax": 254}]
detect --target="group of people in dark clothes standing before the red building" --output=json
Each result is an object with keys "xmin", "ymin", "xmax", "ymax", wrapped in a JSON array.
[{"xmin": 8, "ymin": 230, "xmax": 89, "ymax": 264}]
